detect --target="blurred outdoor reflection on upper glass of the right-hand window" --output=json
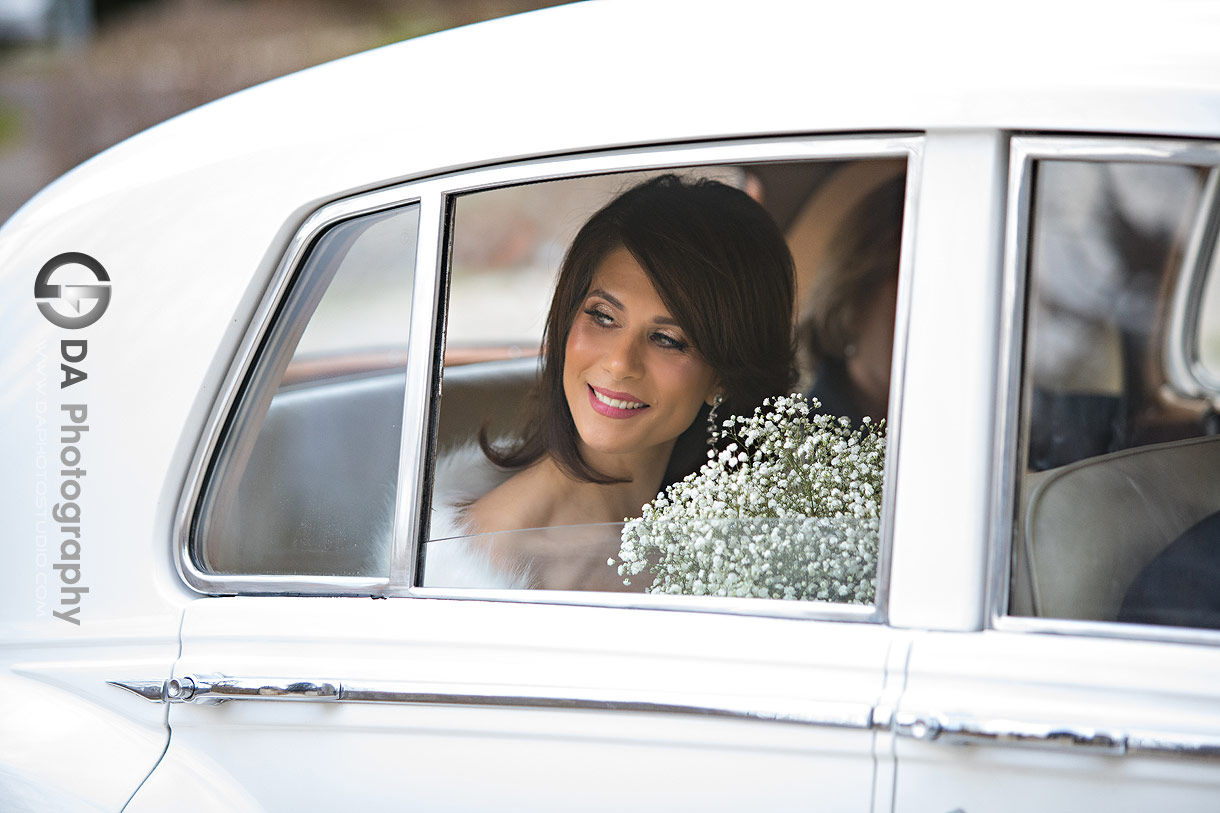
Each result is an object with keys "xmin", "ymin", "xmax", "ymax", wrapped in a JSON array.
[{"xmin": 1025, "ymin": 161, "xmax": 1202, "ymax": 471}]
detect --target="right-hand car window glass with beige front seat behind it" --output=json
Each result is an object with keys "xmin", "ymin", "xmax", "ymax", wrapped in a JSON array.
[{"xmin": 1010, "ymin": 153, "xmax": 1220, "ymax": 627}]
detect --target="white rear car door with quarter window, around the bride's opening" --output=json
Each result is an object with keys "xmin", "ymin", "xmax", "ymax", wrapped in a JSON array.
[{"xmin": 129, "ymin": 137, "xmax": 920, "ymax": 811}]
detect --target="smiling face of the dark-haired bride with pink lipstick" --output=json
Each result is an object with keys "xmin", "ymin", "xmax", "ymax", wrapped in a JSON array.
[{"xmin": 564, "ymin": 248, "xmax": 716, "ymax": 457}]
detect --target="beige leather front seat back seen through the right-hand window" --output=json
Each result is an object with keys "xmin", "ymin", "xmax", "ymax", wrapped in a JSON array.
[{"xmin": 1013, "ymin": 437, "xmax": 1220, "ymax": 621}]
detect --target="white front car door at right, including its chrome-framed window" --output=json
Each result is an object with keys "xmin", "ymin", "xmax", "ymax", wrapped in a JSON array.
[{"xmin": 892, "ymin": 137, "xmax": 1220, "ymax": 811}]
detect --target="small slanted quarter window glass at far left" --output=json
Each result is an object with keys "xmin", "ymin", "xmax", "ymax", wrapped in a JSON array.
[{"xmin": 193, "ymin": 205, "xmax": 418, "ymax": 576}]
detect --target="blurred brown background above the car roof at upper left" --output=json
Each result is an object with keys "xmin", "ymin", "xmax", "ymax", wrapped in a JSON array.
[{"xmin": 0, "ymin": 0, "xmax": 561, "ymax": 223}]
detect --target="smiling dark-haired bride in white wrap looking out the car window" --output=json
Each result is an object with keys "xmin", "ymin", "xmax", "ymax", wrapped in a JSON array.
[{"xmin": 425, "ymin": 175, "xmax": 794, "ymax": 590}]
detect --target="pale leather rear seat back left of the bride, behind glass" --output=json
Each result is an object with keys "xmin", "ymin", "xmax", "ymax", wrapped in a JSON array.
[{"xmin": 211, "ymin": 359, "xmax": 538, "ymax": 576}]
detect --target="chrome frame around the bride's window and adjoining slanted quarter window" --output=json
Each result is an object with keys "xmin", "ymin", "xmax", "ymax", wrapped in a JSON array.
[{"xmin": 174, "ymin": 133, "xmax": 924, "ymax": 623}]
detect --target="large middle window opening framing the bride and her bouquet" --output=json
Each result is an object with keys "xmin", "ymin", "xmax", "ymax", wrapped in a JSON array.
[{"xmin": 421, "ymin": 159, "xmax": 905, "ymax": 604}]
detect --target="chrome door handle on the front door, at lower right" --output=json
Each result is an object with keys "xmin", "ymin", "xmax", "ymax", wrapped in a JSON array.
[{"xmin": 892, "ymin": 712, "xmax": 1127, "ymax": 756}]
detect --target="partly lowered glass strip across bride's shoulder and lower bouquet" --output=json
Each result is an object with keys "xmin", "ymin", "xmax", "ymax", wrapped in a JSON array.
[{"xmin": 423, "ymin": 518, "xmax": 880, "ymax": 604}]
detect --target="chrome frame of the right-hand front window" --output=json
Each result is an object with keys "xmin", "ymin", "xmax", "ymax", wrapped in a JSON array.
[{"xmin": 987, "ymin": 136, "xmax": 1220, "ymax": 646}]
